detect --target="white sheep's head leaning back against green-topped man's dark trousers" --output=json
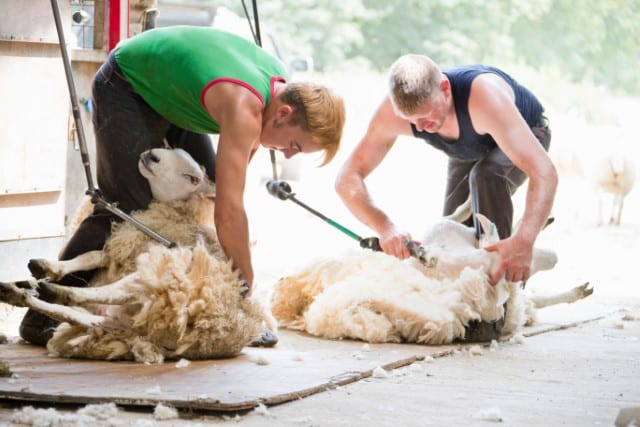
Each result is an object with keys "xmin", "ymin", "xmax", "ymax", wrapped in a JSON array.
[{"xmin": 138, "ymin": 148, "xmax": 215, "ymax": 202}]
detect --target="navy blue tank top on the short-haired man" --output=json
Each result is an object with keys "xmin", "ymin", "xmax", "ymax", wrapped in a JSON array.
[{"xmin": 411, "ymin": 65, "xmax": 544, "ymax": 161}]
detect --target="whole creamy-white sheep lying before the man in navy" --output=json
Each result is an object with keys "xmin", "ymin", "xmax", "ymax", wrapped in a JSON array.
[{"xmin": 272, "ymin": 207, "xmax": 592, "ymax": 344}]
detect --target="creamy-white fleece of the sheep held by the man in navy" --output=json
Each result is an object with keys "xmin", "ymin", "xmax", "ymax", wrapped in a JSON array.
[{"xmin": 271, "ymin": 250, "xmax": 525, "ymax": 344}]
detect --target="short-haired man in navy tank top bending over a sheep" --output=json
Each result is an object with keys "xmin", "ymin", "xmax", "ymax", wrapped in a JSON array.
[{"xmin": 336, "ymin": 54, "xmax": 558, "ymax": 342}]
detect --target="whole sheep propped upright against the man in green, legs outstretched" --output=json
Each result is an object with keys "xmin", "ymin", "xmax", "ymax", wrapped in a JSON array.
[{"xmin": 0, "ymin": 149, "xmax": 275, "ymax": 363}]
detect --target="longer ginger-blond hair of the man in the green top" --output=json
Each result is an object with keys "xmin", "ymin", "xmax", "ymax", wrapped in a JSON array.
[{"xmin": 280, "ymin": 82, "xmax": 346, "ymax": 166}]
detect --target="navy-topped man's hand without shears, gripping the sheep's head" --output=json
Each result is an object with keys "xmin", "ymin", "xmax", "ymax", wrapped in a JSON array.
[{"xmin": 484, "ymin": 235, "xmax": 533, "ymax": 286}]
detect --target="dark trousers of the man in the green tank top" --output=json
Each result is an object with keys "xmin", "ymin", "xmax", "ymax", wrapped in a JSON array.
[{"xmin": 60, "ymin": 54, "xmax": 215, "ymax": 286}]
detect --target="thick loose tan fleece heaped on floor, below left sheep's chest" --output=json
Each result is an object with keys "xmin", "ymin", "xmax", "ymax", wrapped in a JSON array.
[{"xmin": 47, "ymin": 243, "xmax": 265, "ymax": 363}]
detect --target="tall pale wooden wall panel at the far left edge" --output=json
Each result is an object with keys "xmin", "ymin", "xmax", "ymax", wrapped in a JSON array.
[{"xmin": 0, "ymin": 42, "xmax": 70, "ymax": 194}]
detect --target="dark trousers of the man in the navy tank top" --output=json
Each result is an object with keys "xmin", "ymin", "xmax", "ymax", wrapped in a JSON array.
[{"xmin": 443, "ymin": 121, "xmax": 551, "ymax": 239}]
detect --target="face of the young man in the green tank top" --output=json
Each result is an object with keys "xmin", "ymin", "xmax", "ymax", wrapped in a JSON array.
[{"xmin": 260, "ymin": 119, "xmax": 322, "ymax": 159}]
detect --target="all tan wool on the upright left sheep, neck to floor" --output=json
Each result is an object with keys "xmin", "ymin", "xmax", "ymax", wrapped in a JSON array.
[{"xmin": 47, "ymin": 195, "xmax": 275, "ymax": 363}]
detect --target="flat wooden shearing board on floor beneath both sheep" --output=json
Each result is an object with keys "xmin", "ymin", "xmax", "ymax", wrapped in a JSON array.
[{"xmin": 0, "ymin": 302, "xmax": 611, "ymax": 411}]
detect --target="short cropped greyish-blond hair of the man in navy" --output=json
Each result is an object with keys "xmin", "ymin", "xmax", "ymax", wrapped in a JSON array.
[{"xmin": 389, "ymin": 54, "xmax": 442, "ymax": 115}]
